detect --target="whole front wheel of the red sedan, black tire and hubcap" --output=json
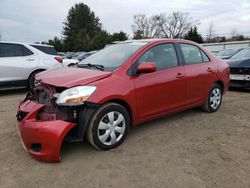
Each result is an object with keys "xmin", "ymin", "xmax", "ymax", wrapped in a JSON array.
[{"xmin": 87, "ymin": 103, "xmax": 131, "ymax": 150}]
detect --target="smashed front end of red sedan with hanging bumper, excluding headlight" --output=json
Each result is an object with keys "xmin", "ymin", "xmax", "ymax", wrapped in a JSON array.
[{"xmin": 17, "ymin": 84, "xmax": 96, "ymax": 162}]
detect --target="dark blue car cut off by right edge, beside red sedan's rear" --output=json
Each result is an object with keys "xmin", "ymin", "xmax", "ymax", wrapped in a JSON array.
[{"xmin": 227, "ymin": 48, "xmax": 250, "ymax": 88}]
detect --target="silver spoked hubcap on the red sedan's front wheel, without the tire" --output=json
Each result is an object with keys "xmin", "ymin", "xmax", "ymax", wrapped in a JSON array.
[{"xmin": 97, "ymin": 111, "xmax": 126, "ymax": 146}]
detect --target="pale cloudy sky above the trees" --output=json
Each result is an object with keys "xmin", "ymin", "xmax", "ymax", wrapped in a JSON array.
[{"xmin": 0, "ymin": 0, "xmax": 250, "ymax": 42}]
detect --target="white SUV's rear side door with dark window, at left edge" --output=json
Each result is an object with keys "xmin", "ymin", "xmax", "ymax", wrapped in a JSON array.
[{"xmin": 0, "ymin": 43, "xmax": 39, "ymax": 82}]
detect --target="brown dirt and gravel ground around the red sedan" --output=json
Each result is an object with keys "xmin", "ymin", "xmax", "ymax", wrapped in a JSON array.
[{"xmin": 0, "ymin": 90, "xmax": 250, "ymax": 188}]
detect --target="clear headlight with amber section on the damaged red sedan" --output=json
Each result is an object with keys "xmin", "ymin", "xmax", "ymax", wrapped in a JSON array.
[{"xmin": 56, "ymin": 86, "xmax": 96, "ymax": 106}]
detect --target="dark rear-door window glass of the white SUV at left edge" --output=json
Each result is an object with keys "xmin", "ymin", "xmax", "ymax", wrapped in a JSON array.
[{"xmin": 0, "ymin": 43, "xmax": 33, "ymax": 57}]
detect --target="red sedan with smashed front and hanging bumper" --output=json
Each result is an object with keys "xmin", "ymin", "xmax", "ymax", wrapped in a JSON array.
[{"xmin": 17, "ymin": 39, "xmax": 229, "ymax": 162}]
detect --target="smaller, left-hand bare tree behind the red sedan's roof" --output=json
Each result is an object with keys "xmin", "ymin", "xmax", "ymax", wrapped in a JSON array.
[{"xmin": 132, "ymin": 14, "xmax": 160, "ymax": 38}]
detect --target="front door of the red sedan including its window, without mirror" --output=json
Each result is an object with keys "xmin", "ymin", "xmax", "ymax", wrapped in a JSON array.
[{"xmin": 134, "ymin": 43, "xmax": 186, "ymax": 119}]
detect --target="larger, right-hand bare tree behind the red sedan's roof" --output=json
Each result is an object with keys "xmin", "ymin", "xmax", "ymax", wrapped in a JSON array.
[{"xmin": 157, "ymin": 12, "xmax": 195, "ymax": 38}]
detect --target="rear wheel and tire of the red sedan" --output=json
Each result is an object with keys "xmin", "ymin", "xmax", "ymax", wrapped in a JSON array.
[{"xmin": 202, "ymin": 84, "xmax": 223, "ymax": 113}]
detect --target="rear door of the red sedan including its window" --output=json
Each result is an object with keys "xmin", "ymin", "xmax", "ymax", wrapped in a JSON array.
[{"xmin": 180, "ymin": 43, "xmax": 215, "ymax": 105}]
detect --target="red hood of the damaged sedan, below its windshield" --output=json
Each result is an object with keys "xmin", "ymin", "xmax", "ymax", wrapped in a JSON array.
[{"xmin": 36, "ymin": 68, "xmax": 112, "ymax": 88}]
